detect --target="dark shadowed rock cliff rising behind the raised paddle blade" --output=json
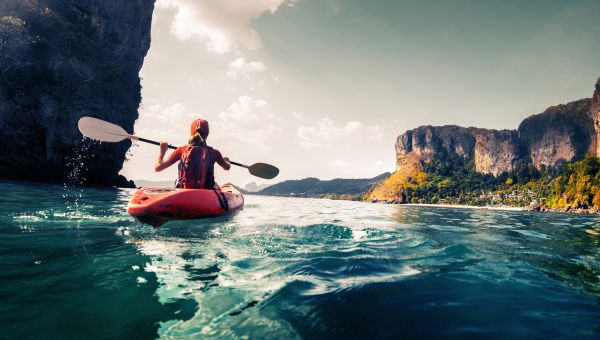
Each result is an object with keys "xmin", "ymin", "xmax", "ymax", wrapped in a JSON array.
[{"xmin": 0, "ymin": 0, "xmax": 154, "ymax": 186}]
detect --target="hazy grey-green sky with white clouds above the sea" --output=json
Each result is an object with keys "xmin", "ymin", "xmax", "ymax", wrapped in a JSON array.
[{"xmin": 121, "ymin": 0, "xmax": 600, "ymax": 186}]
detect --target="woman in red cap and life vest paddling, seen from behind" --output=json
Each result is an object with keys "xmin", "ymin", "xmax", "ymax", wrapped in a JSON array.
[{"xmin": 154, "ymin": 119, "xmax": 231, "ymax": 189}]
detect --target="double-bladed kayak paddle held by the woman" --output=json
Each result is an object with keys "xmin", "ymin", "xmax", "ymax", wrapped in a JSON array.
[{"xmin": 77, "ymin": 117, "xmax": 279, "ymax": 179}]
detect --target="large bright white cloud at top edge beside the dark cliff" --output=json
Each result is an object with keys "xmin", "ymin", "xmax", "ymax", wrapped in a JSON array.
[{"xmin": 156, "ymin": 0, "xmax": 293, "ymax": 54}]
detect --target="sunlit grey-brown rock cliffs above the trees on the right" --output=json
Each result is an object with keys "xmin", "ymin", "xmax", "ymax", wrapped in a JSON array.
[{"xmin": 396, "ymin": 79, "xmax": 600, "ymax": 176}]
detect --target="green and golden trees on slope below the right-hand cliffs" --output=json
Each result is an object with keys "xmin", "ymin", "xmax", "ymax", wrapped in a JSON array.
[{"xmin": 364, "ymin": 150, "xmax": 600, "ymax": 212}]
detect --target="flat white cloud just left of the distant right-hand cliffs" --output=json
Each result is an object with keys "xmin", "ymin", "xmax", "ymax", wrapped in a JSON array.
[{"xmin": 296, "ymin": 117, "xmax": 383, "ymax": 149}]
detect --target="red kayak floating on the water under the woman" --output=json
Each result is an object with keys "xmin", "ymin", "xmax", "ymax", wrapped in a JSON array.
[{"xmin": 127, "ymin": 184, "xmax": 244, "ymax": 227}]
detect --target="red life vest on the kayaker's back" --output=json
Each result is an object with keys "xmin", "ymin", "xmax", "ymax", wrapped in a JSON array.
[{"xmin": 176, "ymin": 146, "xmax": 215, "ymax": 189}]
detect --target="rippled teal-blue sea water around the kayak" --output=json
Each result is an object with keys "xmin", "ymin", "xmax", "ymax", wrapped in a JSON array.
[{"xmin": 0, "ymin": 182, "xmax": 600, "ymax": 339}]
